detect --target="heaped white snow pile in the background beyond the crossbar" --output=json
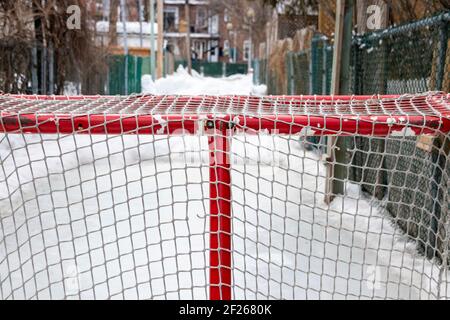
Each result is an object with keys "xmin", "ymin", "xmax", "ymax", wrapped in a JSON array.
[{"xmin": 142, "ymin": 65, "xmax": 267, "ymax": 95}]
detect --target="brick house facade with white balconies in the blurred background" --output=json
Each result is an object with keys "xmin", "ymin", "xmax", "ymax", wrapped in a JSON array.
[{"xmin": 92, "ymin": 0, "xmax": 257, "ymax": 63}]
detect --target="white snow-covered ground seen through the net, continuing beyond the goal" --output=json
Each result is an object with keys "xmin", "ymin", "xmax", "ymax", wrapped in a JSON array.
[{"xmin": 0, "ymin": 71, "xmax": 450, "ymax": 299}]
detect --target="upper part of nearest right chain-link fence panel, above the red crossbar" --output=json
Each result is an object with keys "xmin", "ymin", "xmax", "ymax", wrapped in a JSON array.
[{"xmin": 352, "ymin": 13, "xmax": 450, "ymax": 94}]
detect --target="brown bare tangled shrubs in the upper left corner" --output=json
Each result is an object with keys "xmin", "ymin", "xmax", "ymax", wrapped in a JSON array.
[{"xmin": 0, "ymin": 0, "xmax": 107, "ymax": 94}]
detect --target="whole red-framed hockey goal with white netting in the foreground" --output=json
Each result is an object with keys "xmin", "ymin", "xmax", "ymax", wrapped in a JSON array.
[{"xmin": 0, "ymin": 93, "xmax": 450, "ymax": 300}]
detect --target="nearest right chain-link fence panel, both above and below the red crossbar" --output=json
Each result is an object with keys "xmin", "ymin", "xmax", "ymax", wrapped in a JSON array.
[{"xmin": 348, "ymin": 12, "xmax": 450, "ymax": 261}]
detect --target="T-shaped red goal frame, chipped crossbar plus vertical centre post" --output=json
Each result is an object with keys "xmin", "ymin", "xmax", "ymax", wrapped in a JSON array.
[{"xmin": 0, "ymin": 93, "xmax": 450, "ymax": 300}]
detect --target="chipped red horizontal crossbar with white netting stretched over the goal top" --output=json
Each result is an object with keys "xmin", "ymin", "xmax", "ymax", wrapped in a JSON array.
[{"xmin": 0, "ymin": 94, "xmax": 450, "ymax": 136}]
